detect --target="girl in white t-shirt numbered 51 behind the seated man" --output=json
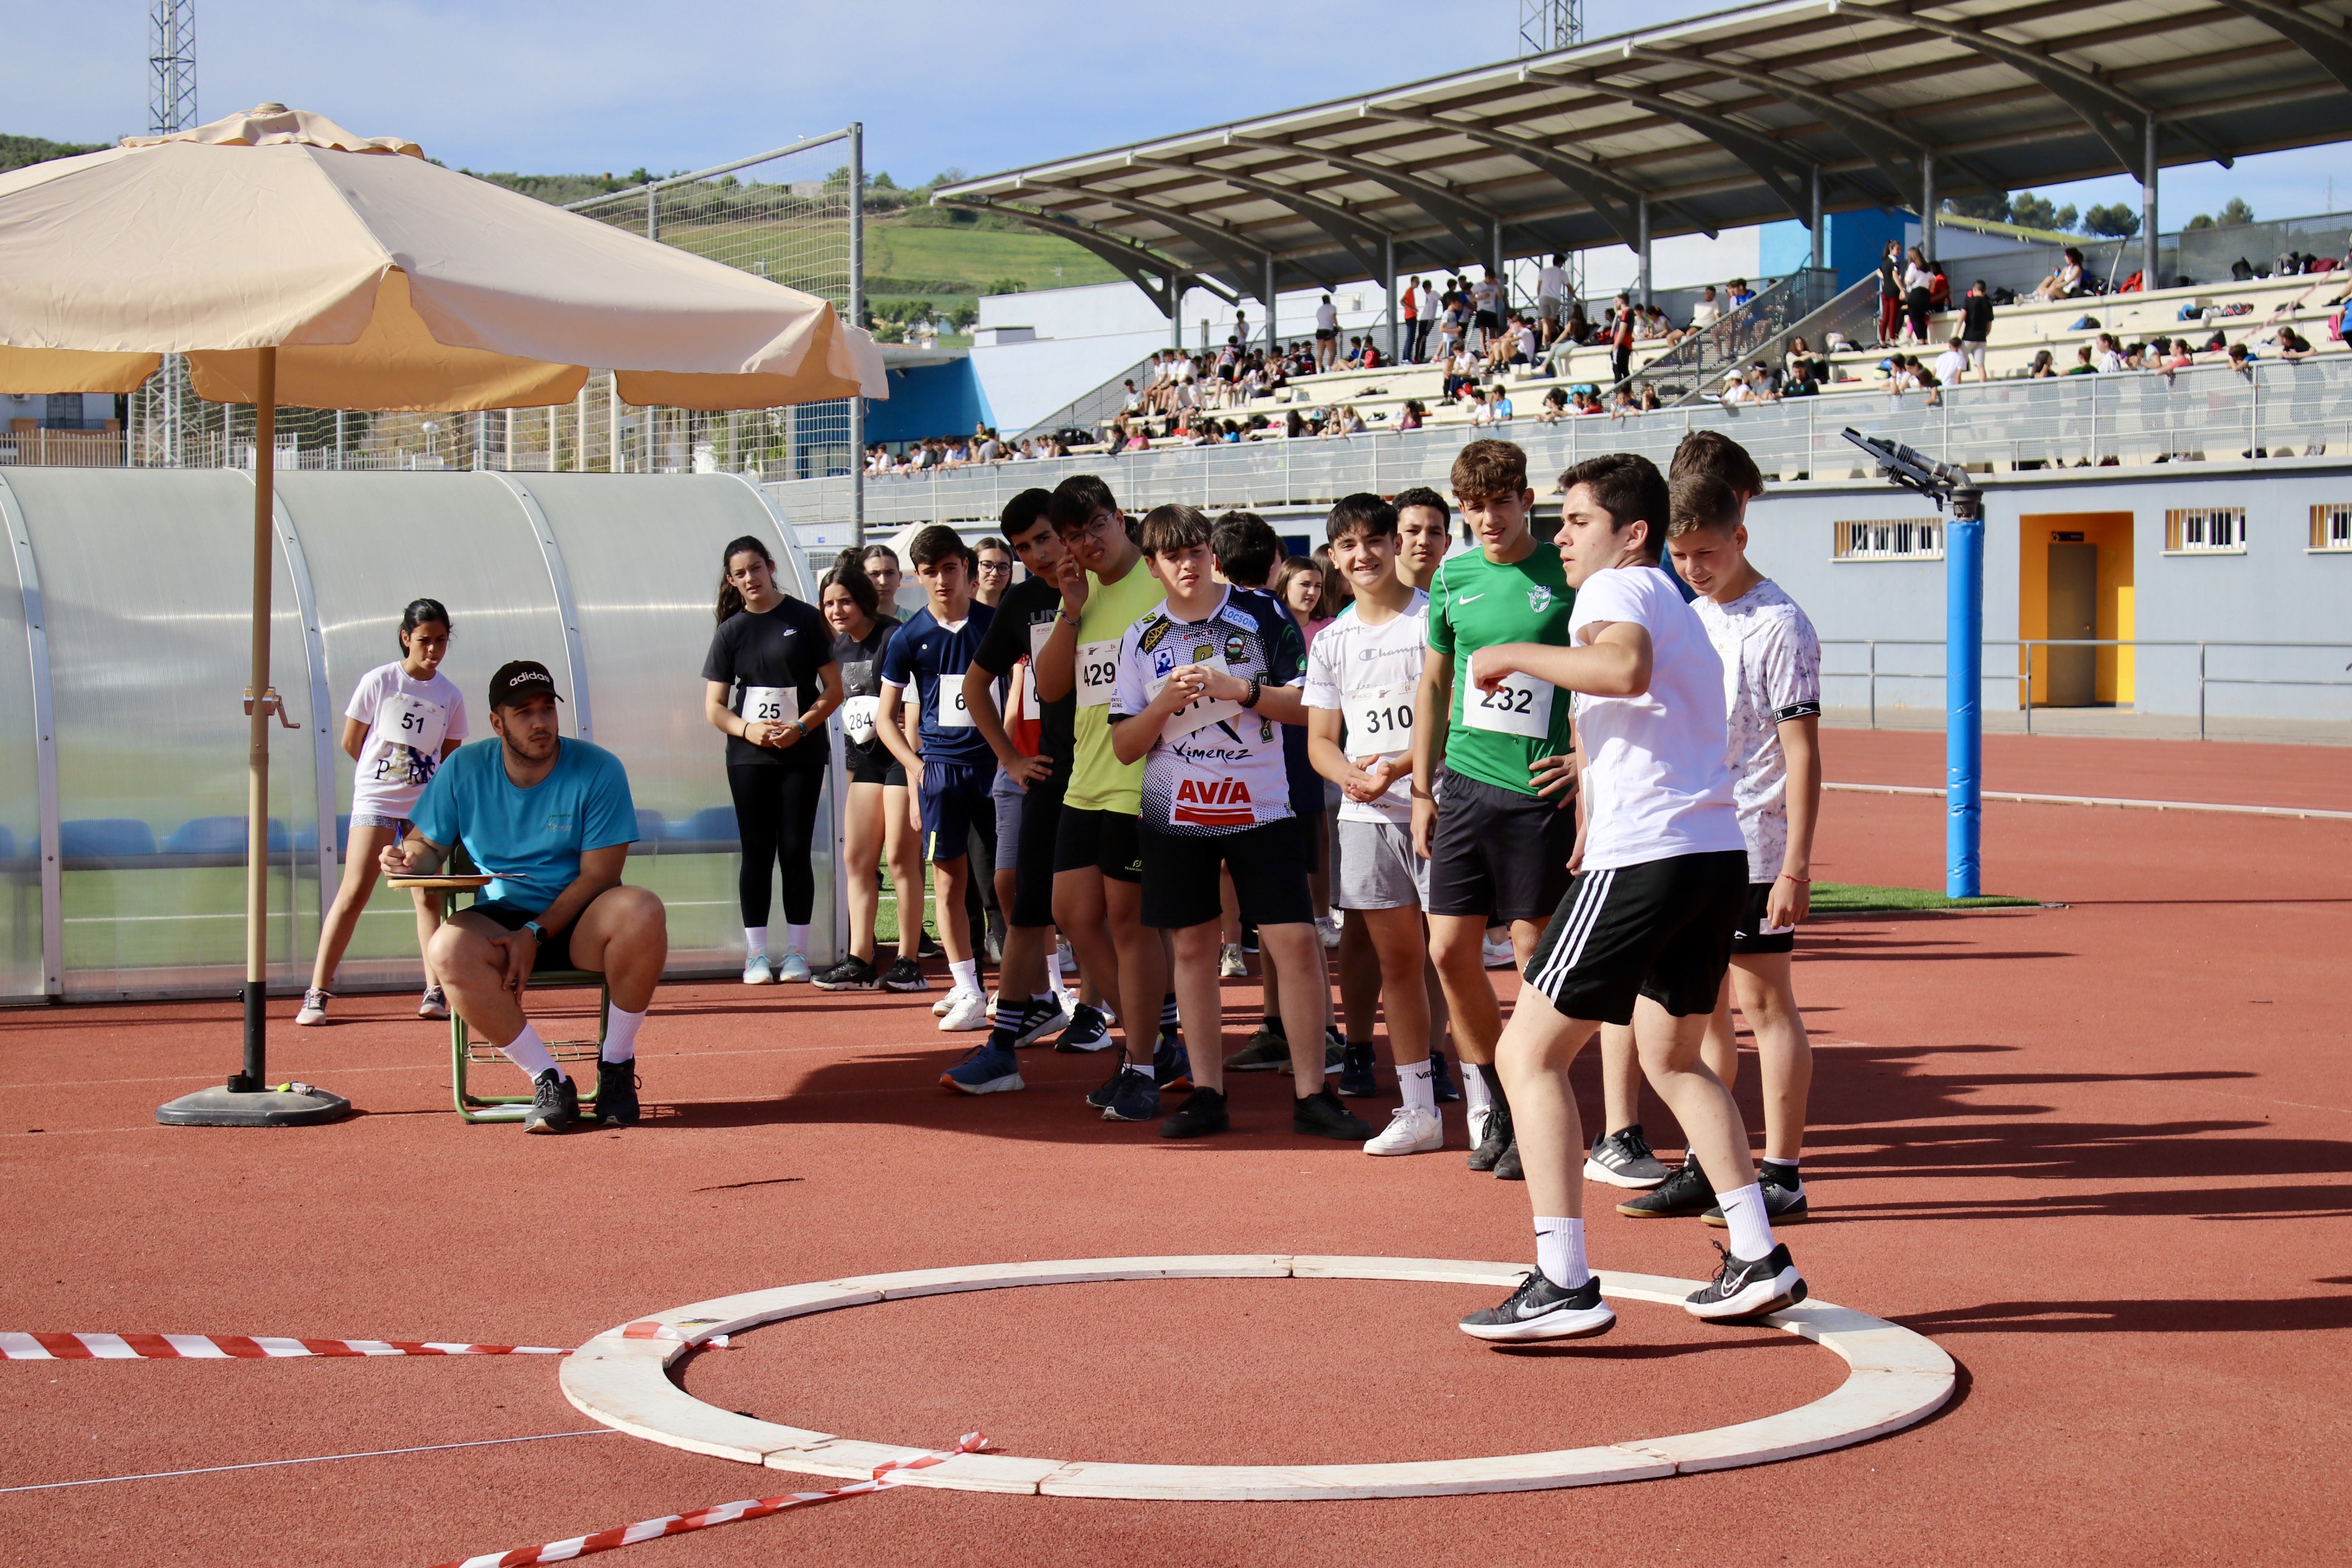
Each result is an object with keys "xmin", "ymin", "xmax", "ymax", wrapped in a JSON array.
[{"xmin": 294, "ymin": 599, "xmax": 466, "ymax": 1025}]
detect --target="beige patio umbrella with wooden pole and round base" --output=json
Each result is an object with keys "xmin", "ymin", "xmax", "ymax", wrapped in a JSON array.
[{"xmin": 0, "ymin": 103, "xmax": 889, "ymax": 1126}]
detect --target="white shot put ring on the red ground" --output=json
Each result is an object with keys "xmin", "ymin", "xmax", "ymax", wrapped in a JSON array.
[{"xmin": 562, "ymin": 1255, "xmax": 1952, "ymax": 1502}]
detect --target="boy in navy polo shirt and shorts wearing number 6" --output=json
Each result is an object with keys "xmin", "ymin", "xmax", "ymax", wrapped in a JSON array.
[{"xmin": 875, "ymin": 522, "xmax": 997, "ymax": 1032}]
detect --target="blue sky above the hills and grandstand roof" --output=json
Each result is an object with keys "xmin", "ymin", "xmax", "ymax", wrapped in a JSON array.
[{"xmin": 0, "ymin": 0, "xmax": 2352, "ymax": 228}]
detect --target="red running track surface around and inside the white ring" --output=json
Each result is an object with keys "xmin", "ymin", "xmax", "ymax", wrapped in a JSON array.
[{"xmin": 0, "ymin": 731, "xmax": 2352, "ymax": 1568}]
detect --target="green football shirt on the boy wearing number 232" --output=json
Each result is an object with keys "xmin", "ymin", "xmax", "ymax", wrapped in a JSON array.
[{"xmin": 1430, "ymin": 541, "xmax": 1576, "ymax": 795}]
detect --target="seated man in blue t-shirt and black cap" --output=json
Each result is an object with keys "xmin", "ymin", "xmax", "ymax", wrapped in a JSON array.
[{"xmin": 383, "ymin": 658, "xmax": 670, "ymax": 1133}]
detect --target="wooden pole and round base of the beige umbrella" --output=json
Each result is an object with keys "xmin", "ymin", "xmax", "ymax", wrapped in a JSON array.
[{"xmin": 155, "ymin": 348, "xmax": 351, "ymax": 1126}]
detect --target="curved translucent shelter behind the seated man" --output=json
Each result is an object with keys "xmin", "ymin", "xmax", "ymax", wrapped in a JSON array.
[{"xmin": 0, "ymin": 468, "xmax": 837, "ymax": 999}]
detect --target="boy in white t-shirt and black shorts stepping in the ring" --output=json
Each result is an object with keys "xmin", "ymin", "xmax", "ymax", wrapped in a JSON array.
[{"xmin": 1461, "ymin": 454, "xmax": 1807, "ymax": 1340}]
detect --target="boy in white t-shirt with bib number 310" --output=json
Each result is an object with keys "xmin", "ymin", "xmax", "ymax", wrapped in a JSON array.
[{"xmin": 1305, "ymin": 494, "xmax": 1446, "ymax": 1154}]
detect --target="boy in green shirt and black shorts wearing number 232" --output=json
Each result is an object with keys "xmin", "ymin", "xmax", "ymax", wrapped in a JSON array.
[{"xmin": 1413, "ymin": 440, "xmax": 1576, "ymax": 1180}]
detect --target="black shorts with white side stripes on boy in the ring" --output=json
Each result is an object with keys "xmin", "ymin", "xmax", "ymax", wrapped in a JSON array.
[{"xmin": 1524, "ymin": 849, "xmax": 1747, "ymax": 1023}]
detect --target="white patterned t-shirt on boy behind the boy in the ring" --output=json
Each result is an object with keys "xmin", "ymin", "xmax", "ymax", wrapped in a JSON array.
[{"xmin": 1691, "ymin": 579, "xmax": 1821, "ymax": 881}]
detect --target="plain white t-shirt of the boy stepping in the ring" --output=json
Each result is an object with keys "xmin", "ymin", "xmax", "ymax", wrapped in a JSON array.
[{"xmin": 1569, "ymin": 567, "xmax": 1747, "ymax": 872}]
